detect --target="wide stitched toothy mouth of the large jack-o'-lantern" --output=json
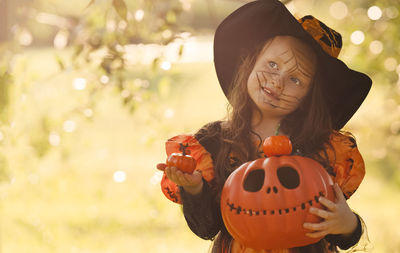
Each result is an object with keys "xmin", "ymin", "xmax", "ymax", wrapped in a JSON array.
[{"xmin": 226, "ymin": 192, "xmax": 325, "ymax": 216}]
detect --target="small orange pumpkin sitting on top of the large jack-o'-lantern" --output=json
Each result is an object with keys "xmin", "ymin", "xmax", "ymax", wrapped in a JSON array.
[{"xmin": 263, "ymin": 135, "xmax": 292, "ymax": 157}]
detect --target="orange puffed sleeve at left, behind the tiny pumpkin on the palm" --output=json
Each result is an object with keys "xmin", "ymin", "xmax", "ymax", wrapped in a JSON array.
[{"xmin": 161, "ymin": 135, "xmax": 214, "ymax": 204}]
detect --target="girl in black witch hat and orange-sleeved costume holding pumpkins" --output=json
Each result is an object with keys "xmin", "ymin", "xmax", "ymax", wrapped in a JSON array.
[{"xmin": 157, "ymin": 0, "xmax": 372, "ymax": 253}]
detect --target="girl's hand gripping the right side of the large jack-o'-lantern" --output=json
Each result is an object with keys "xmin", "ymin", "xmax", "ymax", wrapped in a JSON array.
[{"xmin": 304, "ymin": 184, "xmax": 357, "ymax": 238}]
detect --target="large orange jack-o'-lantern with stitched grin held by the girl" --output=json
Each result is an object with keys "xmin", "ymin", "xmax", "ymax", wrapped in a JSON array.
[{"xmin": 221, "ymin": 137, "xmax": 334, "ymax": 249}]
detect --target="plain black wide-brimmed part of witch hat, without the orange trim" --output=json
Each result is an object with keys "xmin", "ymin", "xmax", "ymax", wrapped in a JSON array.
[{"xmin": 214, "ymin": 0, "xmax": 372, "ymax": 130}]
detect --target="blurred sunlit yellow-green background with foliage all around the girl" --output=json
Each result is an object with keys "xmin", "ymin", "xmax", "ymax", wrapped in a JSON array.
[{"xmin": 0, "ymin": 0, "xmax": 400, "ymax": 252}]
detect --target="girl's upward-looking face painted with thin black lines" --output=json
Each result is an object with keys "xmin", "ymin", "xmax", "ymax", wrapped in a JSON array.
[{"xmin": 247, "ymin": 36, "xmax": 316, "ymax": 117}]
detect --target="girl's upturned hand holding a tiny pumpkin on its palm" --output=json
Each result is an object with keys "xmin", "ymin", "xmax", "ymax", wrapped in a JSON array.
[{"xmin": 157, "ymin": 163, "xmax": 203, "ymax": 195}]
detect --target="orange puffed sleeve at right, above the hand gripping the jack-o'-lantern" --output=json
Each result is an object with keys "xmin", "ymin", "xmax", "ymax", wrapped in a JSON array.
[{"xmin": 328, "ymin": 132, "xmax": 365, "ymax": 198}]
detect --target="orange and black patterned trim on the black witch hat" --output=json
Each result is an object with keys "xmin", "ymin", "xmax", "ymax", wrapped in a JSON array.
[{"xmin": 298, "ymin": 15, "xmax": 342, "ymax": 58}]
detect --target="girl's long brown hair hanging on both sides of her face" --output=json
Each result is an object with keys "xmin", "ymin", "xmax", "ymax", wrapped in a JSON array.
[{"xmin": 213, "ymin": 38, "xmax": 334, "ymax": 253}]
